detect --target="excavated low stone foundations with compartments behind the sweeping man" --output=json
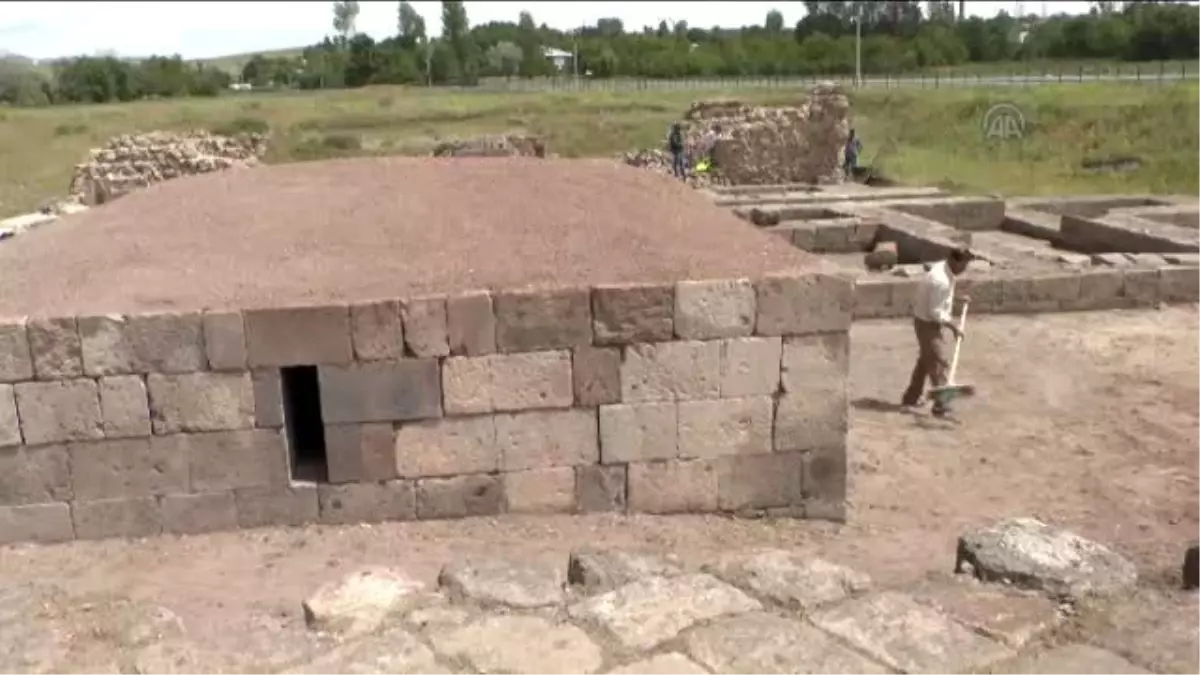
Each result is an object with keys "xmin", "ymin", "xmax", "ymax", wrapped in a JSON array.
[{"xmin": 708, "ymin": 185, "xmax": 1200, "ymax": 318}]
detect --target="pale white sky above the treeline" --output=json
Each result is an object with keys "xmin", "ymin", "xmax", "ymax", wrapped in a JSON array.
[{"xmin": 0, "ymin": 0, "xmax": 1088, "ymax": 59}]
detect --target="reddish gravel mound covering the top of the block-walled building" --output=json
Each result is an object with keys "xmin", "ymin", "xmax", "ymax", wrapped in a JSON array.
[{"xmin": 0, "ymin": 157, "xmax": 821, "ymax": 315}]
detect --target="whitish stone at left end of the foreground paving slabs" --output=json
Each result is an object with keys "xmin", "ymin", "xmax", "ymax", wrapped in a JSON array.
[{"xmin": 304, "ymin": 567, "xmax": 425, "ymax": 635}]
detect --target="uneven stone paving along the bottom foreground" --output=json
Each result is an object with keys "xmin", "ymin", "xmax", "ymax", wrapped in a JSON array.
[{"xmin": 0, "ymin": 519, "xmax": 1200, "ymax": 675}]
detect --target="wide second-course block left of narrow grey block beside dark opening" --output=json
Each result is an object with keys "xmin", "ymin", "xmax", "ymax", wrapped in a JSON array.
[{"xmin": 146, "ymin": 372, "xmax": 254, "ymax": 435}]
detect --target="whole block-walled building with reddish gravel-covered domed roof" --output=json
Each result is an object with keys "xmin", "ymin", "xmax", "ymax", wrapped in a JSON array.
[{"xmin": 0, "ymin": 160, "xmax": 852, "ymax": 542}]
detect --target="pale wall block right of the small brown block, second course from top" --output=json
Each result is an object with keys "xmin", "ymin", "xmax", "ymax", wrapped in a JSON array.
[{"xmin": 620, "ymin": 341, "xmax": 721, "ymax": 404}]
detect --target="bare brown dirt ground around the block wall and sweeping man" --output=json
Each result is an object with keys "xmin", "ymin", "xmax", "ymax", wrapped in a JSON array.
[{"xmin": 0, "ymin": 307, "xmax": 1200, "ymax": 670}]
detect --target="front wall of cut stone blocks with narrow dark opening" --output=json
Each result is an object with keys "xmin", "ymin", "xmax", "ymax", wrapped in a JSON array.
[{"xmin": 0, "ymin": 267, "xmax": 853, "ymax": 543}]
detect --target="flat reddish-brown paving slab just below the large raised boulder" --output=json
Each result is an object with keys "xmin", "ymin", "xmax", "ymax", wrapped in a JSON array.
[{"xmin": 914, "ymin": 571, "xmax": 1064, "ymax": 649}]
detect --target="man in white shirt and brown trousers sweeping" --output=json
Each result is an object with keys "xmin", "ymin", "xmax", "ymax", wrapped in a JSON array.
[{"xmin": 901, "ymin": 249, "xmax": 971, "ymax": 417}]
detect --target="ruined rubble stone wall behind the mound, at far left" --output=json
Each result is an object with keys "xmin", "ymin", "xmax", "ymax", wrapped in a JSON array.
[{"xmin": 71, "ymin": 131, "xmax": 268, "ymax": 205}]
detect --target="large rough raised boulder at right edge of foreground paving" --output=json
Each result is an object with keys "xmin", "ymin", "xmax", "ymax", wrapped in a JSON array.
[{"xmin": 954, "ymin": 518, "xmax": 1138, "ymax": 598}]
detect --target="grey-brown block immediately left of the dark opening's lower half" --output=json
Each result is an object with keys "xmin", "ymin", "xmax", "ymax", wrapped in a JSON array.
[{"xmin": 165, "ymin": 429, "xmax": 288, "ymax": 492}]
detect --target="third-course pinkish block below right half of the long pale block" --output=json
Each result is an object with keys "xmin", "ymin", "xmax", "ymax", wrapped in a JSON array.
[{"xmin": 496, "ymin": 408, "xmax": 600, "ymax": 471}]
